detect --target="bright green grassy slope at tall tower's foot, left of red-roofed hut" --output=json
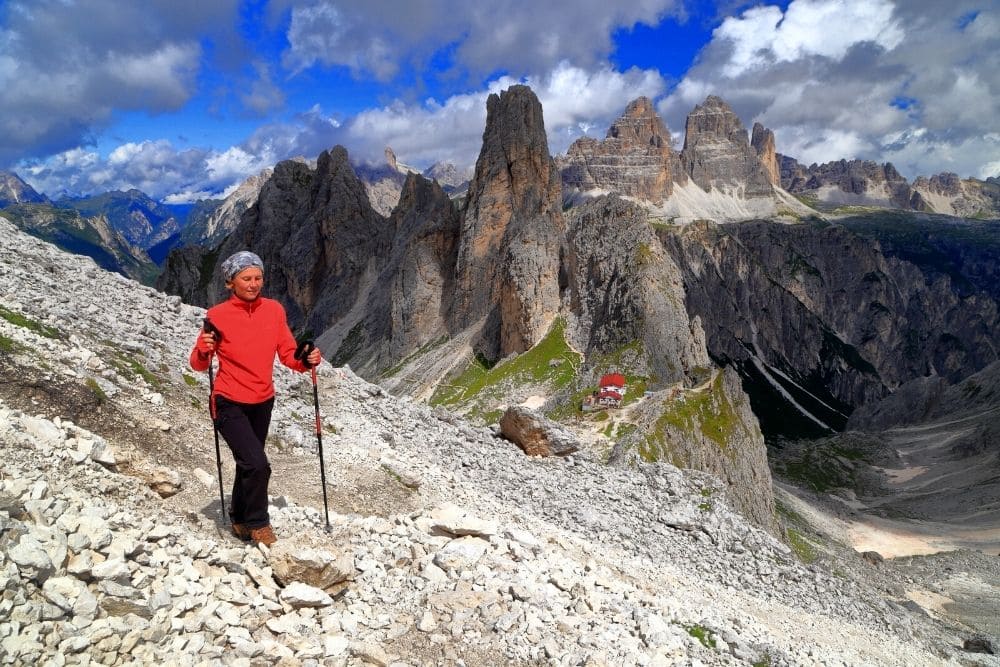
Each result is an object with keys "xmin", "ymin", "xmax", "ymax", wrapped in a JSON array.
[{"xmin": 430, "ymin": 318, "xmax": 580, "ymax": 406}]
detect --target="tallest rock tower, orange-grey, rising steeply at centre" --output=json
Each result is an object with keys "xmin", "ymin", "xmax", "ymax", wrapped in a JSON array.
[{"xmin": 449, "ymin": 86, "xmax": 565, "ymax": 357}]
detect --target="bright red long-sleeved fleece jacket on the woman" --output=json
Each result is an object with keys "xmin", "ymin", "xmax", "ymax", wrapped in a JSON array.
[{"xmin": 190, "ymin": 296, "xmax": 308, "ymax": 403}]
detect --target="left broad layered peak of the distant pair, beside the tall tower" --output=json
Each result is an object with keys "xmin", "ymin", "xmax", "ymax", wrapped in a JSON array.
[{"xmin": 561, "ymin": 97, "xmax": 686, "ymax": 204}]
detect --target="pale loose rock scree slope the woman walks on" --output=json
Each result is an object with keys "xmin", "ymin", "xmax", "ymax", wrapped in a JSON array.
[{"xmin": 0, "ymin": 220, "xmax": 1000, "ymax": 667}]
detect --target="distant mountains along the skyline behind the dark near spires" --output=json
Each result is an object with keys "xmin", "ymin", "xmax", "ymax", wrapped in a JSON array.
[{"xmin": 0, "ymin": 96, "xmax": 1000, "ymax": 288}]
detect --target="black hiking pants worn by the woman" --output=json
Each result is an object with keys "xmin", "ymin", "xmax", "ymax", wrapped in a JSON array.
[{"xmin": 215, "ymin": 394, "xmax": 274, "ymax": 528}]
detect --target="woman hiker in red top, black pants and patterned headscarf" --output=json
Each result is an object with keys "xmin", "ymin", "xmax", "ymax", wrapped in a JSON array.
[{"xmin": 190, "ymin": 250, "xmax": 322, "ymax": 546}]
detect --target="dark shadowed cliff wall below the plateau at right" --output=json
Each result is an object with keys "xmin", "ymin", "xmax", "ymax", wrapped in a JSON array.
[{"xmin": 661, "ymin": 222, "xmax": 998, "ymax": 432}]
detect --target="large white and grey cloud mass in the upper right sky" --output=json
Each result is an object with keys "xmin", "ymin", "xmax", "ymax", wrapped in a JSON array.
[{"xmin": 658, "ymin": 0, "xmax": 1000, "ymax": 178}]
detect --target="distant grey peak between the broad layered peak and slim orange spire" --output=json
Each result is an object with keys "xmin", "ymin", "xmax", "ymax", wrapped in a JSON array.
[{"xmin": 681, "ymin": 95, "xmax": 774, "ymax": 197}]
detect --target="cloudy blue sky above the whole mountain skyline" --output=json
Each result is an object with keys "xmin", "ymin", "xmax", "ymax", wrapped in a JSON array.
[{"xmin": 0, "ymin": 0, "xmax": 1000, "ymax": 202}]
